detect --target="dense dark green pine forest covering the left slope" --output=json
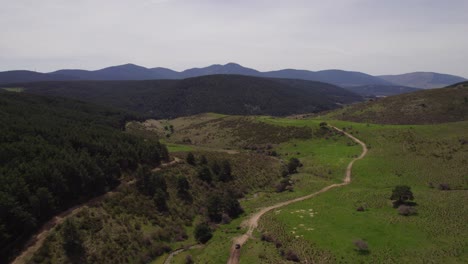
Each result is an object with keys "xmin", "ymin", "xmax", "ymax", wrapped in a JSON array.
[{"xmin": 0, "ymin": 92, "xmax": 168, "ymax": 262}]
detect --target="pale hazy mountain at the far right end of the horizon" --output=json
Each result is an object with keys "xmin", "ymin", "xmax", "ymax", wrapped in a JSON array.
[{"xmin": 377, "ymin": 72, "xmax": 466, "ymax": 89}]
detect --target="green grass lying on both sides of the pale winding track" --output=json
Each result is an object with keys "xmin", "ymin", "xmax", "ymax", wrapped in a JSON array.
[{"xmin": 119, "ymin": 114, "xmax": 468, "ymax": 263}]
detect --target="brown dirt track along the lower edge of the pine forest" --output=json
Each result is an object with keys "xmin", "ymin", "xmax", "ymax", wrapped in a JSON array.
[{"xmin": 11, "ymin": 158, "xmax": 181, "ymax": 264}]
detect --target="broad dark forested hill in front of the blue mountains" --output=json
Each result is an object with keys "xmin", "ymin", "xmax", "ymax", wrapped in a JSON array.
[{"xmin": 9, "ymin": 75, "xmax": 362, "ymax": 118}]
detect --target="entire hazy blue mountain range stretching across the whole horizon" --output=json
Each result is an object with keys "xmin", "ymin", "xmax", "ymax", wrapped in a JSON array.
[{"xmin": 0, "ymin": 63, "xmax": 466, "ymax": 89}]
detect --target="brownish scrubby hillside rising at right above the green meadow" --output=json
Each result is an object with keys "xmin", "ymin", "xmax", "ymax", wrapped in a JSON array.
[{"xmin": 329, "ymin": 82, "xmax": 468, "ymax": 124}]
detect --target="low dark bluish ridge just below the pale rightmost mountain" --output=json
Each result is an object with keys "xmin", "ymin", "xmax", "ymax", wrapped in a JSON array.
[{"xmin": 344, "ymin": 84, "xmax": 421, "ymax": 96}]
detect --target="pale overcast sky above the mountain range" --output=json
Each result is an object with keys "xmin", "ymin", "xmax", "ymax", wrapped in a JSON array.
[{"xmin": 0, "ymin": 0, "xmax": 468, "ymax": 78}]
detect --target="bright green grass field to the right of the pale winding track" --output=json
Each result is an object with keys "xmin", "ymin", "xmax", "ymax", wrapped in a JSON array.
[{"xmin": 261, "ymin": 120, "xmax": 468, "ymax": 263}]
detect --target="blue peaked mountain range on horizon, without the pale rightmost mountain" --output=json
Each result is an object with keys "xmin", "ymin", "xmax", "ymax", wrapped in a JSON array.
[{"xmin": 0, "ymin": 63, "xmax": 398, "ymax": 86}]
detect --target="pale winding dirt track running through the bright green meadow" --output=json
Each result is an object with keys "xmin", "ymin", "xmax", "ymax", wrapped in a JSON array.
[{"xmin": 227, "ymin": 126, "xmax": 367, "ymax": 264}]
